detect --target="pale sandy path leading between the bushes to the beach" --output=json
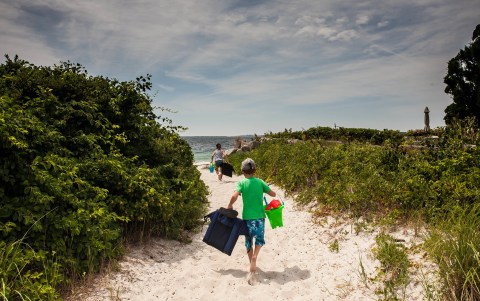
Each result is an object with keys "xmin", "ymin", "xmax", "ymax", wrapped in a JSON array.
[{"xmin": 68, "ymin": 166, "xmax": 428, "ymax": 301}]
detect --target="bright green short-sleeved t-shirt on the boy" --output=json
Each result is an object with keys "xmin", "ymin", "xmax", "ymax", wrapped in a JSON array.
[{"xmin": 236, "ymin": 177, "xmax": 270, "ymax": 220}]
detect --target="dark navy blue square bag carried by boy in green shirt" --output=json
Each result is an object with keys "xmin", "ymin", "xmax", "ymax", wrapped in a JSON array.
[{"xmin": 203, "ymin": 208, "xmax": 247, "ymax": 256}]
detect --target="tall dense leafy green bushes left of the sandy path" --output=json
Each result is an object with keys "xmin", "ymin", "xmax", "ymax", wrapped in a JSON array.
[{"xmin": 0, "ymin": 56, "xmax": 208, "ymax": 300}]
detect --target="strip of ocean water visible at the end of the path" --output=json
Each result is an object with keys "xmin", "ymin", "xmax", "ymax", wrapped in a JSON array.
[{"xmin": 182, "ymin": 136, "xmax": 238, "ymax": 164}]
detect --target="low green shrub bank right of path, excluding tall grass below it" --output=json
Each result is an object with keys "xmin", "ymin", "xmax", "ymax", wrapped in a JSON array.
[{"xmin": 233, "ymin": 119, "xmax": 480, "ymax": 219}]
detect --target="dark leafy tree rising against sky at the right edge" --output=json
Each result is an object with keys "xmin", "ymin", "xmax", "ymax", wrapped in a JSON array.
[{"xmin": 444, "ymin": 24, "xmax": 480, "ymax": 127}]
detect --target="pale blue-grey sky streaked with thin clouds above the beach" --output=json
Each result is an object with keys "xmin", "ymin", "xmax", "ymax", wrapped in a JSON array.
[{"xmin": 0, "ymin": 0, "xmax": 480, "ymax": 136}]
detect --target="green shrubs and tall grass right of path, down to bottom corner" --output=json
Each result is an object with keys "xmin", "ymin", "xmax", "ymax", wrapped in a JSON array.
[{"xmin": 229, "ymin": 119, "xmax": 480, "ymax": 300}]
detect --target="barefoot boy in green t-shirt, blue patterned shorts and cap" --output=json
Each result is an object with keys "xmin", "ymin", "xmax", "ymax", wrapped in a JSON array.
[{"xmin": 227, "ymin": 158, "xmax": 276, "ymax": 285}]
